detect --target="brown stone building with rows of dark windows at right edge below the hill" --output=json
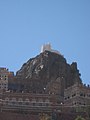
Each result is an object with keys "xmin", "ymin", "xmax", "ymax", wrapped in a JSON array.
[{"xmin": 64, "ymin": 84, "xmax": 90, "ymax": 106}]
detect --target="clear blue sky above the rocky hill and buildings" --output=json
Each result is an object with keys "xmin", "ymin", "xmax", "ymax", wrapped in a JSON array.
[{"xmin": 0, "ymin": 0, "xmax": 90, "ymax": 84}]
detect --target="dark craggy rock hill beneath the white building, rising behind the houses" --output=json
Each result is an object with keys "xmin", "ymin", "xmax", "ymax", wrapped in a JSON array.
[{"xmin": 12, "ymin": 51, "xmax": 81, "ymax": 96}]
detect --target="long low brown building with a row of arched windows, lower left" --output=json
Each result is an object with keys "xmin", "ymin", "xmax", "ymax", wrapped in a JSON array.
[{"xmin": 0, "ymin": 92, "xmax": 61, "ymax": 111}]
